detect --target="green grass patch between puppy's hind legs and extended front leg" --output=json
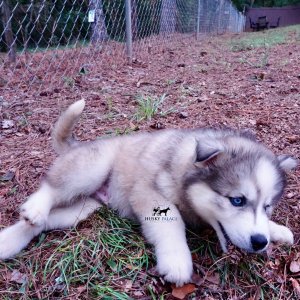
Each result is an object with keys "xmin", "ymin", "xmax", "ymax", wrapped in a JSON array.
[{"xmin": 0, "ymin": 208, "xmax": 152, "ymax": 299}]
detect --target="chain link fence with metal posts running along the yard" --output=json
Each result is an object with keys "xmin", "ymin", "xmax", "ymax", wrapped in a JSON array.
[{"xmin": 0, "ymin": 0, "xmax": 245, "ymax": 94}]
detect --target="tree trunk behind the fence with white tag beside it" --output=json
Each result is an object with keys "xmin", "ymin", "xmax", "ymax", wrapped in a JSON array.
[{"xmin": 90, "ymin": 0, "xmax": 109, "ymax": 43}]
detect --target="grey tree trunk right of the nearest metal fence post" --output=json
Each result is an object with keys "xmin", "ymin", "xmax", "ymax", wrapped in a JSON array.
[{"xmin": 160, "ymin": 0, "xmax": 177, "ymax": 34}]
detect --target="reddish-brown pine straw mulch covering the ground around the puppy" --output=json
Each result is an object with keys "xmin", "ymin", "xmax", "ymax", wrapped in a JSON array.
[{"xmin": 0, "ymin": 27, "xmax": 300, "ymax": 299}]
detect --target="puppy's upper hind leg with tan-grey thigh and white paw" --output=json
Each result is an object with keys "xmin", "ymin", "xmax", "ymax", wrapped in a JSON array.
[{"xmin": 21, "ymin": 143, "xmax": 114, "ymax": 226}]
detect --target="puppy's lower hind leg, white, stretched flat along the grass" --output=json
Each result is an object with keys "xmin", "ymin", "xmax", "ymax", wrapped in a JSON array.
[{"xmin": 0, "ymin": 198, "xmax": 101, "ymax": 259}]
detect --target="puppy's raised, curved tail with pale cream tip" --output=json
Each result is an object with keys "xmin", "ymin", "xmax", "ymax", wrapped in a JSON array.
[{"xmin": 52, "ymin": 99, "xmax": 85, "ymax": 154}]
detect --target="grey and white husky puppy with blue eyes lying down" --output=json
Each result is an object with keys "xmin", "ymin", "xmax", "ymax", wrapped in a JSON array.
[{"xmin": 0, "ymin": 100, "xmax": 297, "ymax": 286}]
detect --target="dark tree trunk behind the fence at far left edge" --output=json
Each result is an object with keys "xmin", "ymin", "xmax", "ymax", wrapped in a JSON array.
[{"xmin": 2, "ymin": 0, "xmax": 16, "ymax": 62}]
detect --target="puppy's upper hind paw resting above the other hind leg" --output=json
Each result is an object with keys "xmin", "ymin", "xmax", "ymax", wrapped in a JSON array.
[{"xmin": 20, "ymin": 199, "xmax": 49, "ymax": 226}]
